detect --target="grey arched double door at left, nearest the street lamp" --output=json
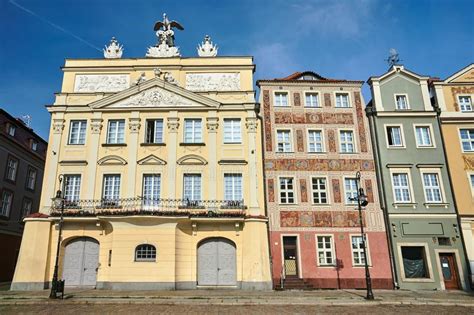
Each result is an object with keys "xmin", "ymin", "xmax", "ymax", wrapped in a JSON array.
[{"xmin": 63, "ymin": 237, "xmax": 99, "ymax": 286}]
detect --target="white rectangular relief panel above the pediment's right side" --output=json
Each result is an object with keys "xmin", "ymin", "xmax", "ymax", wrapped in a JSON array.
[{"xmin": 186, "ymin": 73, "xmax": 240, "ymax": 92}]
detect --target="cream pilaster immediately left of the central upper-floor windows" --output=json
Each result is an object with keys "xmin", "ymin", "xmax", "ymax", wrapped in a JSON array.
[{"xmin": 124, "ymin": 111, "xmax": 141, "ymax": 198}]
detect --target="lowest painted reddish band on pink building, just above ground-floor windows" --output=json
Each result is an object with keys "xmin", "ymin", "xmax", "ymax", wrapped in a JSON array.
[{"xmin": 280, "ymin": 210, "xmax": 367, "ymax": 228}]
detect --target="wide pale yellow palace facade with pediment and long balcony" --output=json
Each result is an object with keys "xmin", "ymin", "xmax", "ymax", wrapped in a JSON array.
[{"xmin": 12, "ymin": 31, "xmax": 272, "ymax": 290}]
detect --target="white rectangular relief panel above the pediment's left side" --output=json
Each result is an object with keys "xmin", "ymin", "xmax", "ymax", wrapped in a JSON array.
[{"xmin": 74, "ymin": 74, "xmax": 130, "ymax": 93}]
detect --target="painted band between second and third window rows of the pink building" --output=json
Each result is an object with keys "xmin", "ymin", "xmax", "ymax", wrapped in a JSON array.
[{"xmin": 265, "ymin": 159, "xmax": 375, "ymax": 172}]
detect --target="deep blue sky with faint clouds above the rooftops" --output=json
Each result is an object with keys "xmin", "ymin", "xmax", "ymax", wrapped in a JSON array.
[{"xmin": 0, "ymin": 0, "xmax": 474, "ymax": 139}]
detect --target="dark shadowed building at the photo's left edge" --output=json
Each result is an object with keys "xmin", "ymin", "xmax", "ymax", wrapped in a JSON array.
[{"xmin": 0, "ymin": 109, "xmax": 47, "ymax": 282}]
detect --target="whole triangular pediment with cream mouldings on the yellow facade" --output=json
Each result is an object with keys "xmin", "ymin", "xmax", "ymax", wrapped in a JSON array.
[{"xmin": 89, "ymin": 78, "xmax": 220, "ymax": 109}]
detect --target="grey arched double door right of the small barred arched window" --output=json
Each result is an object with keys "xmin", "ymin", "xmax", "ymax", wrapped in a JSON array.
[{"xmin": 198, "ymin": 237, "xmax": 237, "ymax": 286}]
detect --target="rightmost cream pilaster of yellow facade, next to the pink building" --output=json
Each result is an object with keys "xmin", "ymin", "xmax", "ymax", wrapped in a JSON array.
[{"xmin": 245, "ymin": 115, "xmax": 263, "ymax": 215}]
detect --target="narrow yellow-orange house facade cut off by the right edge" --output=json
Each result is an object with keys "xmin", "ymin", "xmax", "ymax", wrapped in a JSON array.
[{"xmin": 431, "ymin": 64, "xmax": 474, "ymax": 285}]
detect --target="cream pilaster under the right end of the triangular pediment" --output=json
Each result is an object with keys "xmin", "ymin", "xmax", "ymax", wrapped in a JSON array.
[{"xmin": 206, "ymin": 112, "xmax": 222, "ymax": 200}]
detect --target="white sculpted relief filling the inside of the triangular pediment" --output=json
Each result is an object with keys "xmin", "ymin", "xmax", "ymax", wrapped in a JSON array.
[{"xmin": 113, "ymin": 88, "xmax": 192, "ymax": 107}]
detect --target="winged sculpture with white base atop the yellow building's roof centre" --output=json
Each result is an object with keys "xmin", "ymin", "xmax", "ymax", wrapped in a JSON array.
[{"xmin": 146, "ymin": 13, "xmax": 184, "ymax": 58}]
